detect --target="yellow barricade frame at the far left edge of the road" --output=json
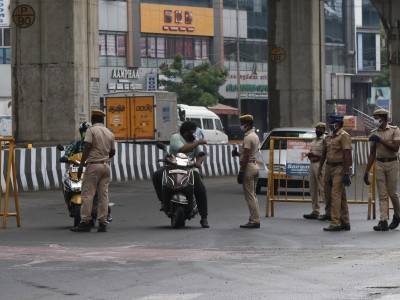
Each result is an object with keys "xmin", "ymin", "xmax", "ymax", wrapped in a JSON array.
[{"xmin": 0, "ymin": 138, "xmax": 21, "ymax": 228}]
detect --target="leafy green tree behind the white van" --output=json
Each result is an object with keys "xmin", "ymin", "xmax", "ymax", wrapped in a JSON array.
[{"xmin": 160, "ymin": 55, "xmax": 228, "ymax": 106}]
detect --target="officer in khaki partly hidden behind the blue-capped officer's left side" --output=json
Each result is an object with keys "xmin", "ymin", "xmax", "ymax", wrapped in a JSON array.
[{"xmin": 303, "ymin": 122, "xmax": 326, "ymax": 219}]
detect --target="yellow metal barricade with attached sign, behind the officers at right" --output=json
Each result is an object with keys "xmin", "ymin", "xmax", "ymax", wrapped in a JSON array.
[{"xmin": 265, "ymin": 137, "xmax": 376, "ymax": 220}]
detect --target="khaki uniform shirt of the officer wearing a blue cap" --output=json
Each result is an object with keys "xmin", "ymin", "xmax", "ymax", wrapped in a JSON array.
[{"xmin": 324, "ymin": 128, "xmax": 352, "ymax": 163}]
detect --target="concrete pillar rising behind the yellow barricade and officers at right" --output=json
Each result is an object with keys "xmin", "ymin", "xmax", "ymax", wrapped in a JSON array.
[{"xmin": 268, "ymin": 0, "xmax": 325, "ymax": 129}]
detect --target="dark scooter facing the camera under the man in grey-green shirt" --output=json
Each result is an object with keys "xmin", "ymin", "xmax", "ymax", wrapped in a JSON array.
[{"xmin": 157, "ymin": 143, "xmax": 205, "ymax": 228}]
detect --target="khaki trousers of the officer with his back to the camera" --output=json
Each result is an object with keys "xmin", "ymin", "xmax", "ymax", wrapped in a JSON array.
[{"xmin": 81, "ymin": 163, "xmax": 111, "ymax": 224}]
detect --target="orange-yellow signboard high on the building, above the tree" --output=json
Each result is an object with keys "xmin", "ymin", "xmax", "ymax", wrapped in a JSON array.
[{"xmin": 140, "ymin": 3, "xmax": 214, "ymax": 36}]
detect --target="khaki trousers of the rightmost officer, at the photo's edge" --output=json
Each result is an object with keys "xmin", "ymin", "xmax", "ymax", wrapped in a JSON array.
[{"xmin": 375, "ymin": 161, "xmax": 400, "ymax": 220}]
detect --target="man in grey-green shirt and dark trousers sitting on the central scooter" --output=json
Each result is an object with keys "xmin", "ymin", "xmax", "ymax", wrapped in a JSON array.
[{"xmin": 152, "ymin": 121, "xmax": 210, "ymax": 228}]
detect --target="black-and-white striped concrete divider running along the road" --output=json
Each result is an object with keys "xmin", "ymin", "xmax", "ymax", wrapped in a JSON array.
[{"xmin": 1, "ymin": 143, "xmax": 239, "ymax": 192}]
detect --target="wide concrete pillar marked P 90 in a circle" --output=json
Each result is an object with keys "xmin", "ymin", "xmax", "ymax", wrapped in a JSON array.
[{"xmin": 10, "ymin": 0, "xmax": 100, "ymax": 146}]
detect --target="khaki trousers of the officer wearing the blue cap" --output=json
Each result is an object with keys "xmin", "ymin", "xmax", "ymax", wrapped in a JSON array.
[{"xmin": 324, "ymin": 165, "xmax": 350, "ymax": 227}]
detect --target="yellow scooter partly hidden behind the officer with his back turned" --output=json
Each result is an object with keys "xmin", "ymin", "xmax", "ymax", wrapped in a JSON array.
[{"xmin": 57, "ymin": 145, "xmax": 112, "ymax": 227}]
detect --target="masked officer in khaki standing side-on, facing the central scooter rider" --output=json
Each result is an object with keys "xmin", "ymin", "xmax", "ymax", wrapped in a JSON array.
[{"xmin": 232, "ymin": 115, "xmax": 260, "ymax": 228}]
